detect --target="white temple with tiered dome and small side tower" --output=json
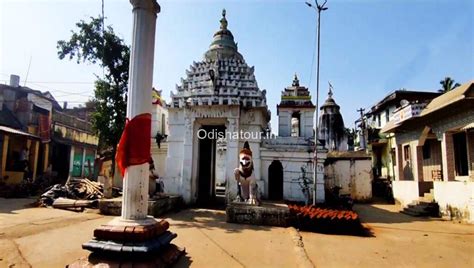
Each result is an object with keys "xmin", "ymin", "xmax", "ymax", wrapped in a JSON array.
[{"xmin": 164, "ymin": 10, "xmax": 325, "ymax": 203}]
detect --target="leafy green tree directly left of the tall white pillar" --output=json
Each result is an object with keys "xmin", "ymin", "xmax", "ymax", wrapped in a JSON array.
[{"xmin": 57, "ymin": 17, "xmax": 130, "ymax": 176}]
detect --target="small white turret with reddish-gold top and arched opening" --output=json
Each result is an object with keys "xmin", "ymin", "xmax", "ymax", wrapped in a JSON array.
[{"xmin": 277, "ymin": 74, "xmax": 316, "ymax": 138}]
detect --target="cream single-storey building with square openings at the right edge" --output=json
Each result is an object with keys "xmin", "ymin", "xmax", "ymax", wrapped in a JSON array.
[{"xmin": 381, "ymin": 81, "xmax": 474, "ymax": 222}]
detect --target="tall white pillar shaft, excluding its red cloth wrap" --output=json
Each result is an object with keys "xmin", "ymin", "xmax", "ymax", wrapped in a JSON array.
[{"xmin": 121, "ymin": 0, "xmax": 160, "ymax": 221}]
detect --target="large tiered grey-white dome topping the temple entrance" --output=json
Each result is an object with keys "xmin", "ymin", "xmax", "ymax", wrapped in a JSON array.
[{"xmin": 170, "ymin": 10, "xmax": 269, "ymax": 111}]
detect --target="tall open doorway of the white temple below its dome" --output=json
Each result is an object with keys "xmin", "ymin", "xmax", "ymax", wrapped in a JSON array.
[{"xmin": 196, "ymin": 125, "xmax": 226, "ymax": 207}]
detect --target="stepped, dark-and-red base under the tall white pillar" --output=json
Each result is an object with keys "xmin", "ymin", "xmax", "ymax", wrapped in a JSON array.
[{"xmin": 74, "ymin": 217, "xmax": 185, "ymax": 267}]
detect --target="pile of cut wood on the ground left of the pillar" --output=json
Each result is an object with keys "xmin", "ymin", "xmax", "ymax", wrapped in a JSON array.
[{"xmin": 39, "ymin": 178, "xmax": 104, "ymax": 206}]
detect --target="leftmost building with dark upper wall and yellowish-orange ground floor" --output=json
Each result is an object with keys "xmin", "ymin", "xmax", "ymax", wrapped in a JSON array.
[{"xmin": 0, "ymin": 75, "xmax": 60, "ymax": 184}]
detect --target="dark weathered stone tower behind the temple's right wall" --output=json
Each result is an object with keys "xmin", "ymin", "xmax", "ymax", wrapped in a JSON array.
[{"xmin": 318, "ymin": 85, "xmax": 348, "ymax": 151}]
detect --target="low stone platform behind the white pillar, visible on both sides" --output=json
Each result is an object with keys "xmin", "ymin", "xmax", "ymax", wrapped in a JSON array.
[{"xmin": 99, "ymin": 195, "xmax": 183, "ymax": 217}]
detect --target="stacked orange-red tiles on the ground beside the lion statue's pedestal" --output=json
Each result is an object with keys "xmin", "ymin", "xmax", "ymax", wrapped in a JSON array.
[{"xmin": 288, "ymin": 204, "xmax": 367, "ymax": 236}]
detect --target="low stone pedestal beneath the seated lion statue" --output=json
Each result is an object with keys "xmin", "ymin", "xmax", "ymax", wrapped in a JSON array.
[{"xmin": 225, "ymin": 201, "xmax": 291, "ymax": 227}]
